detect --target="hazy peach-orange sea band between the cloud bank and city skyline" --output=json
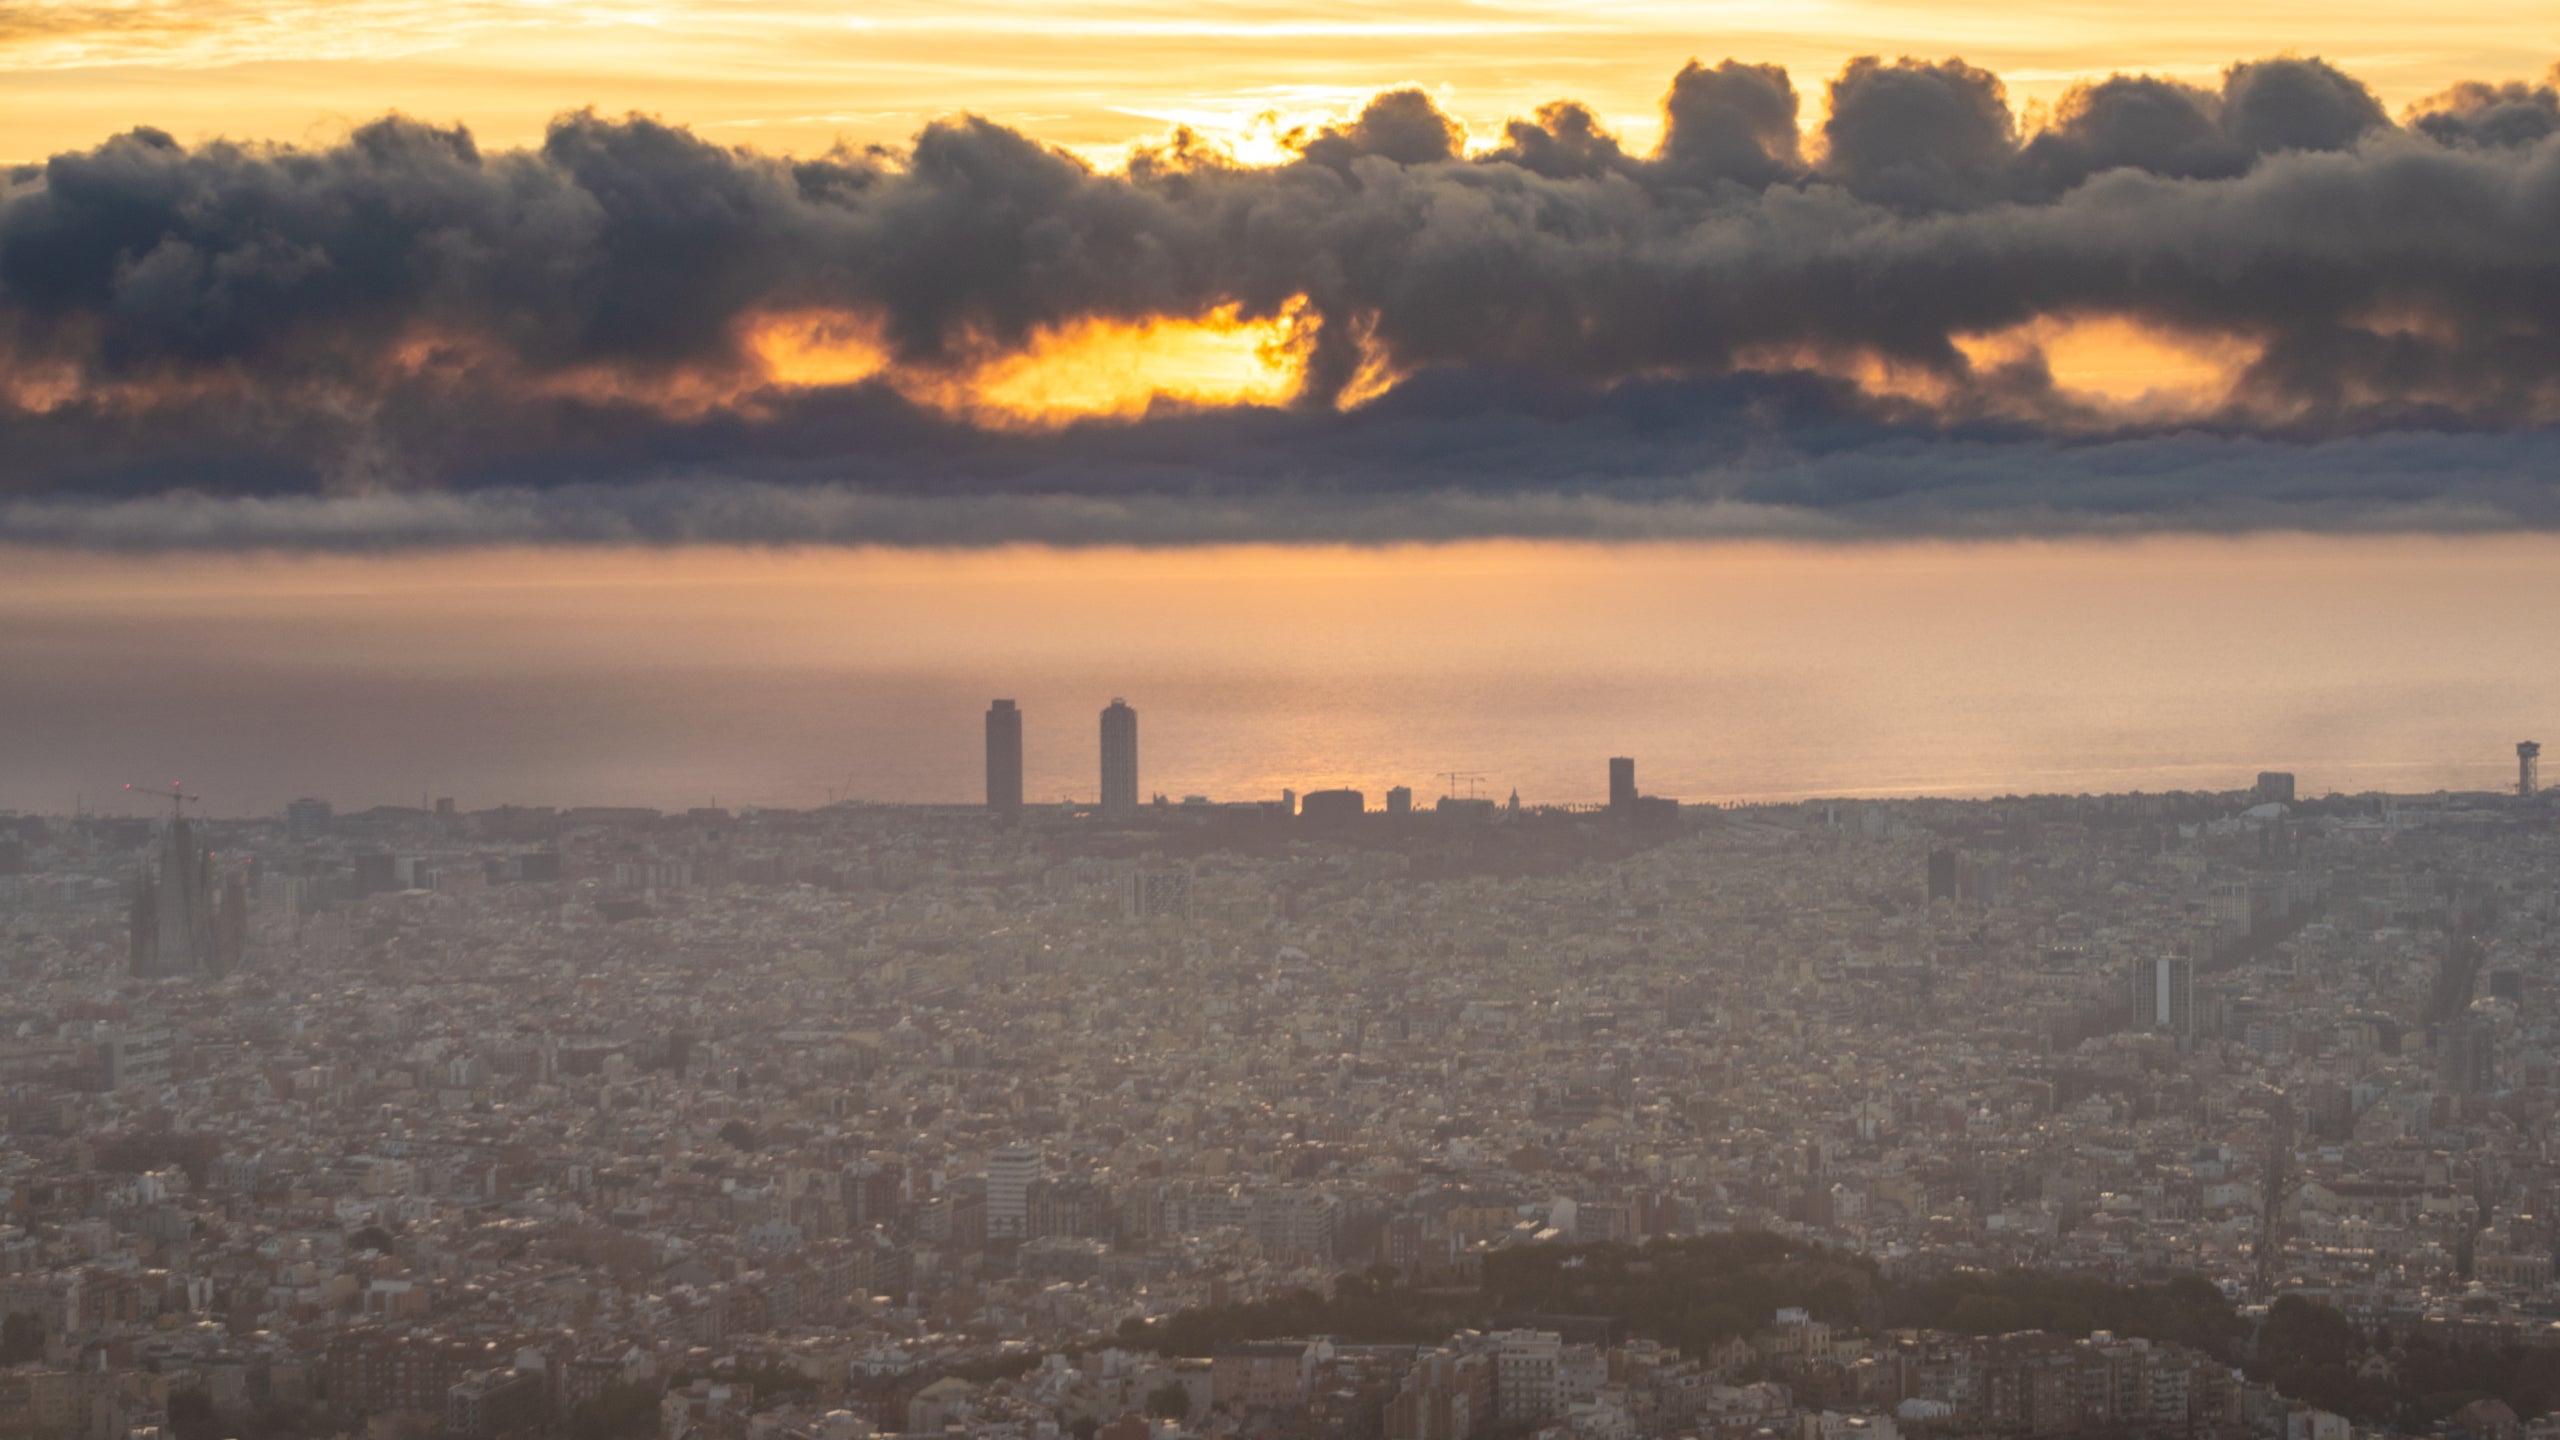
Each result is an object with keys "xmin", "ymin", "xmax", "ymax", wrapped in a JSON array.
[{"xmin": 0, "ymin": 536, "xmax": 2560, "ymax": 815}]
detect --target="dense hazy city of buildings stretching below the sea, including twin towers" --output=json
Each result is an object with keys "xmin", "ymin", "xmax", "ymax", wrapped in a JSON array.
[{"xmin": 0, "ymin": 700, "xmax": 2560, "ymax": 1440}]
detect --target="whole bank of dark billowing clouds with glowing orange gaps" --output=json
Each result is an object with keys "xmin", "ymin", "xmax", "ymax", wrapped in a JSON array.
[{"xmin": 0, "ymin": 59, "xmax": 2560, "ymax": 543}]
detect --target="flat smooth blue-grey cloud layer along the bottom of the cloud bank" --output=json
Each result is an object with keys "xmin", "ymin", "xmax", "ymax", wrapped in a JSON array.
[{"xmin": 20, "ymin": 422, "xmax": 2560, "ymax": 551}]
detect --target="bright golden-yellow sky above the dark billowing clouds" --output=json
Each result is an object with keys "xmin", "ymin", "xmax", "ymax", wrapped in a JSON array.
[{"xmin": 0, "ymin": 0, "xmax": 2560, "ymax": 161}]
